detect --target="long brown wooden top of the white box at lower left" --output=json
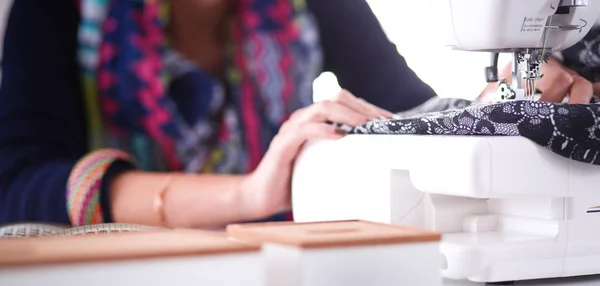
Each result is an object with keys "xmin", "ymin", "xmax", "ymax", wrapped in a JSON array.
[{"xmin": 0, "ymin": 230, "xmax": 260, "ymax": 267}]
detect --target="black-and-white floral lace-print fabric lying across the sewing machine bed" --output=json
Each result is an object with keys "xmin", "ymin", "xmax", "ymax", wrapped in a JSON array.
[{"xmin": 350, "ymin": 99, "xmax": 600, "ymax": 165}]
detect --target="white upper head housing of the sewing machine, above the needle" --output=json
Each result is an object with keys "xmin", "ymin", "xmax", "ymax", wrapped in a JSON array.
[{"xmin": 431, "ymin": 0, "xmax": 600, "ymax": 52}]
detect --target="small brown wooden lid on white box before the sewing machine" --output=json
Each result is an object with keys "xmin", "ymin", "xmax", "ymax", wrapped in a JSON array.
[{"xmin": 227, "ymin": 221, "xmax": 441, "ymax": 248}]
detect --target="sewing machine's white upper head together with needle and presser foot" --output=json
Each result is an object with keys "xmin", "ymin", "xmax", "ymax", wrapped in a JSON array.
[{"xmin": 440, "ymin": 0, "xmax": 600, "ymax": 100}]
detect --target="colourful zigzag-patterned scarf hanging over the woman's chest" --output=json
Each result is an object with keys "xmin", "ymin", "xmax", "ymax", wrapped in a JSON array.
[{"xmin": 79, "ymin": 0, "xmax": 321, "ymax": 173}]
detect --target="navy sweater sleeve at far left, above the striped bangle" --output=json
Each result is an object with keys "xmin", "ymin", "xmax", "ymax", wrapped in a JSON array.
[{"xmin": 0, "ymin": 0, "xmax": 86, "ymax": 224}]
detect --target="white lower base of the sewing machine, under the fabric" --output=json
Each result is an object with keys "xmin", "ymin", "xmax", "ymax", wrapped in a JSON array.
[{"xmin": 292, "ymin": 135, "xmax": 600, "ymax": 285}]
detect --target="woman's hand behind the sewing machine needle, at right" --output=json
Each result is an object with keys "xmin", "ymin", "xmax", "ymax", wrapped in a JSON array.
[{"xmin": 485, "ymin": 57, "xmax": 594, "ymax": 104}]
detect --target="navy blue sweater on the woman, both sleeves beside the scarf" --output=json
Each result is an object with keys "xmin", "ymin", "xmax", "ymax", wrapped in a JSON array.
[{"xmin": 0, "ymin": 0, "xmax": 435, "ymax": 224}]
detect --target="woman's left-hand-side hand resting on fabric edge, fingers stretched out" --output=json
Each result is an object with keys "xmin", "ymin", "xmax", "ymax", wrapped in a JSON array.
[{"xmin": 240, "ymin": 90, "xmax": 392, "ymax": 217}]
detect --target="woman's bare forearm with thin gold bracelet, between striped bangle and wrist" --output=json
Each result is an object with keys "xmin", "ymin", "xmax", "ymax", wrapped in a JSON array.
[{"xmin": 110, "ymin": 171, "xmax": 254, "ymax": 228}]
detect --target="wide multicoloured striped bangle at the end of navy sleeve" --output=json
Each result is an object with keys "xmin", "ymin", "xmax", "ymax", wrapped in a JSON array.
[{"xmin": 67, "ymin": 149, "xmax": 132, "ymax": 226}]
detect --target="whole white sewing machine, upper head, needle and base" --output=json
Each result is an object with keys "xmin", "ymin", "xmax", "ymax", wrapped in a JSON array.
[{"xmin": 292, "ymin": 0, "xmax": 600, "ymax": 282}]
